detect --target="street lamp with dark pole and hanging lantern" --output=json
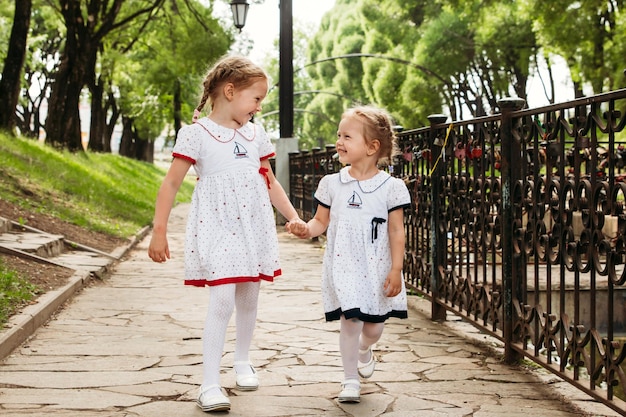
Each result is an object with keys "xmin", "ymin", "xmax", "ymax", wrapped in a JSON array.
[{"xmin": 230, "ymin": 0, "xmax": 293, "ymax": 139}]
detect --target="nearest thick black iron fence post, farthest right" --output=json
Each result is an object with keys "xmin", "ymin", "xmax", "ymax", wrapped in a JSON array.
[{"xmin": 498, "ymin": 97, "xmax": 526, "ymax": 363}]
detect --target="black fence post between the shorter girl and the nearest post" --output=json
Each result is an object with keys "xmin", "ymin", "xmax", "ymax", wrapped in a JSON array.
[{"xmin": 428, "ymin": 114, "xmax": 448, "ymax": 321}]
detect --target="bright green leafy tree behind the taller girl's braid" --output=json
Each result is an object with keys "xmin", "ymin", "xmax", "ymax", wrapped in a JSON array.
[{"xmin": 111, "ymin": 1, "xmax": 233, "ymax": 160}]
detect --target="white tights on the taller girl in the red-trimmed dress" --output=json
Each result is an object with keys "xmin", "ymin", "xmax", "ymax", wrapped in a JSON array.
[{"xmin": 202, "ymin": 282, "xmax": 261, "ymax": 392}]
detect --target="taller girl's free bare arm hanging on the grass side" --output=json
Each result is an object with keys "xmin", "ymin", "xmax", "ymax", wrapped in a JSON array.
[{"xmin": 148, "ymin": 158, "xmax": 191, "ymax": 262}]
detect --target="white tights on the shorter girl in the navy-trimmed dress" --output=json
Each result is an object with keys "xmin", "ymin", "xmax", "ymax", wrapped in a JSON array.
[{"xmin": 339, "ymin": 316, "xmax": 385, "ymax": 381}]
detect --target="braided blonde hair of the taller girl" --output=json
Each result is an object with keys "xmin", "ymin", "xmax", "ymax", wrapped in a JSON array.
[{"xmin": 196, "ymin": 55, "xmax": 267, "ymax": 112}]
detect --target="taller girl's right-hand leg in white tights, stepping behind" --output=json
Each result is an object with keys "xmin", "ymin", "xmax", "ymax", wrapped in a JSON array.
[{"xmin": 234, "ymin": 282, "xmax": 261, "ymax": 375}]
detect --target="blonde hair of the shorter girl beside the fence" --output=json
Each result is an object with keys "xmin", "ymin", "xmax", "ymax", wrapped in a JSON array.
[{"xmin": 341, "ymin": 105, "xmax": 399, "ymax": 165}]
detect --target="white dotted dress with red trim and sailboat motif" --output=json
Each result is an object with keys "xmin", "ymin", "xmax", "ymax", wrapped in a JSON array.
[{"xmin": 173, "ymin": 117, "xmax": 281, "ymax": 287}]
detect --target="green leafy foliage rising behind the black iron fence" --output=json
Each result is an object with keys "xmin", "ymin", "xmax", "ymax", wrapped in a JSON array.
[{"xmin": 296, "ymin": 0, "xmax": 626, "ymax": 147}]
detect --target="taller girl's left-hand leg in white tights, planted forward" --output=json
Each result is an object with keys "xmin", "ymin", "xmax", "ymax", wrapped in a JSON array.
[{"xmin": 202, "ymin": 284, "xmax": 235, "ymax": 395}]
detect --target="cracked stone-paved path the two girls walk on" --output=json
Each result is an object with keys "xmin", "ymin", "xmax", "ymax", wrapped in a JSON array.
[{"xmin": 0, "ymin": 205, "xmax": 618, "ymax": 417}]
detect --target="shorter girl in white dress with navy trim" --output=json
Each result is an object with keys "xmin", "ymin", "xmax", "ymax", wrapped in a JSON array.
[{"xmin": 288, "ymin": 106, "xmax": 410, "ymax": 402}]
